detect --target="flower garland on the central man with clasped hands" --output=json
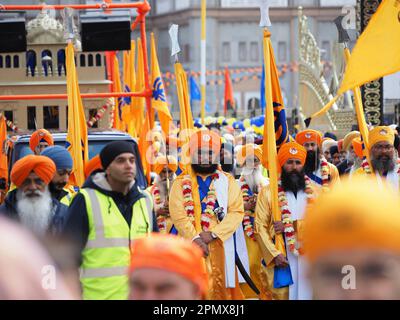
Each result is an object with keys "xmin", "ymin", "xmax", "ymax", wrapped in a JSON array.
[{"xmin": 182, "ymin": 173, "xmax": 219, "ymax": 231}]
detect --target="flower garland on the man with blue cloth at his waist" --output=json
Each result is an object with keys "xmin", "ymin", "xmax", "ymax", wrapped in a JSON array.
[{"xmin": 278, "ymin": 176, "xmax": 314, "ymax": 256}]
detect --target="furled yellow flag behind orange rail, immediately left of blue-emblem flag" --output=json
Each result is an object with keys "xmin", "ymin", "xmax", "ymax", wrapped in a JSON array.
[{"xmin": 131, "ymin": 38, "xmax": 145, "ymax": 133}]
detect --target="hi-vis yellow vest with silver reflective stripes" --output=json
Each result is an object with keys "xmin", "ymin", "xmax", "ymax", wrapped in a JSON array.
[{"xmin": 80, "ymin": 189, "xmax": 153, "ymax": 300}]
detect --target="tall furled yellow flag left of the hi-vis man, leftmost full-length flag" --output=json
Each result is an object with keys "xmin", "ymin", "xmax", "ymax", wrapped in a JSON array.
[{"xmin": 66, "ymin": 43, "xmax": 89, "ymax": 186}]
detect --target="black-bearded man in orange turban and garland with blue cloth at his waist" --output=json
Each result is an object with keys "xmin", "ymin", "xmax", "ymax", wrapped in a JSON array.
[{"xmin": 255, "ymin": 142, "xmax": 316, "ymax": 300}]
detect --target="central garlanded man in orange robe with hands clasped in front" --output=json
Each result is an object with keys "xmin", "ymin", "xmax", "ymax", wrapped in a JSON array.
[{"xmin": 170, "ymin": 130, "xmax": 246, "ymax": 300}]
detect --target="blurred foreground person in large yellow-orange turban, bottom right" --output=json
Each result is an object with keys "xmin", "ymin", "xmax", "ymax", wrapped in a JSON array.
[{"xmin": 304, "ymin": 176, "xmax": 400, "ymax": 300}]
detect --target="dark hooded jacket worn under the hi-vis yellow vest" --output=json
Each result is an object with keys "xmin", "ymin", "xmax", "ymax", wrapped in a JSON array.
[{"xmin": 63, "ymin": 173, "xmax": 158, "ymax": 264}]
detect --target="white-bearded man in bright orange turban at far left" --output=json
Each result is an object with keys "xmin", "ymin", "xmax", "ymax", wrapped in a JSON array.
[{"xmin": 0, "ymin": 155, "xmax": 68, "ymax": 236}]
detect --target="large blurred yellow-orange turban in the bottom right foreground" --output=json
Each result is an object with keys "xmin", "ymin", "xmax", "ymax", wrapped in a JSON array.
[{"xmin": 304, "ymin": 176, "xmax": 400, "ymax": 262}]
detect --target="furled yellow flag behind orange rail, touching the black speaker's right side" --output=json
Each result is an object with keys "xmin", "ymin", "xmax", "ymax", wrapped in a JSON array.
[{"xmin": 122, "ymin": 41, "xmax": 137, "ymax": 137}]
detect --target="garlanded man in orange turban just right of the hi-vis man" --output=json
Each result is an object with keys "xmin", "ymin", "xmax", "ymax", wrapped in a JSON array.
[{"xmin": 150, "ymin": 156, "xmax": 178, "ymax": 234}]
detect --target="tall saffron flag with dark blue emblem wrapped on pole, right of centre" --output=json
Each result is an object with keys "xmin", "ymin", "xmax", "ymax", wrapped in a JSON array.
[{"xmin": 262, "ymin": 29, "xmax": 289, "ymax": 260}]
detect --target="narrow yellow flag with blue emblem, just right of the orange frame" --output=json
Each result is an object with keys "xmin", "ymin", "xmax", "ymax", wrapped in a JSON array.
[{"xmin": 151, "ymin": 33, "xmax": 172, "ymax": 135}]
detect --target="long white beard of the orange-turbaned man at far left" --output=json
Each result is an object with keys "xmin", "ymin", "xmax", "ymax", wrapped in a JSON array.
[{"xmin": 17, "ymin": 187, "xmax": 53, "ymax": 236}]
